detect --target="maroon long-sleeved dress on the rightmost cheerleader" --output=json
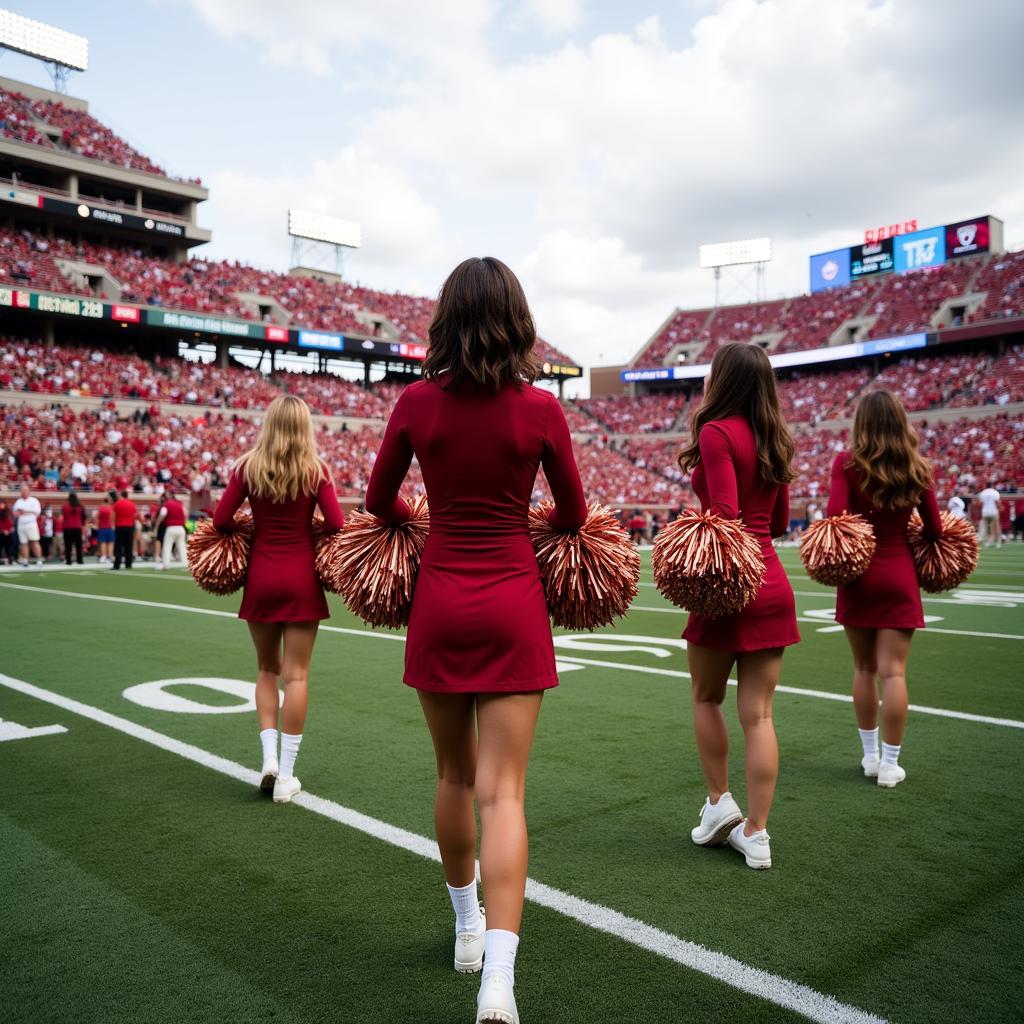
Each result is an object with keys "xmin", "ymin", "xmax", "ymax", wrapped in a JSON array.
[{"xmin": 826, "ymin": 452, "xmax": 942, "ymax": 630}]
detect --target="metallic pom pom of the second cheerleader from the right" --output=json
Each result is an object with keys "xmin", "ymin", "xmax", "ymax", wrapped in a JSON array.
[{"xmin": 651, "ymin": 509, "xmax": 765, "ymax": 618}]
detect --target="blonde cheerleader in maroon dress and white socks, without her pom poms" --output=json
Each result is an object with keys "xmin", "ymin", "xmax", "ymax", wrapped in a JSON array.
[{"xmin": 213, "ymin": 395, "xmax": 343, "ymax": 804}]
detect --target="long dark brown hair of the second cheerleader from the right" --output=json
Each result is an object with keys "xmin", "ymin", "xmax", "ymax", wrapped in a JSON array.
[{"xmin": 679, "ymin": 341, "xmax": 797, "ymax": 483}]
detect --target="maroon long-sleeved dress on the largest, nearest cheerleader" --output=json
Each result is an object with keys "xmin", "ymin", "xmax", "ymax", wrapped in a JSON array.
[{"xmin": 367, "ymin": 374, "xmax": 587, "ymax": 693}]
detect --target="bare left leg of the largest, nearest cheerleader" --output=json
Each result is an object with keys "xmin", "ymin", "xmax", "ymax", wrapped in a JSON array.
[{"xmin": 419, "ymin": 690, "xmax": 476, "ymax": 889}]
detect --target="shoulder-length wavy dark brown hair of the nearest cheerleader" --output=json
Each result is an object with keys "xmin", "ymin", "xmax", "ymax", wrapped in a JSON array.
[{"xmin": 423, "ymin": 256, "xmax": 539, "ymax": 391}]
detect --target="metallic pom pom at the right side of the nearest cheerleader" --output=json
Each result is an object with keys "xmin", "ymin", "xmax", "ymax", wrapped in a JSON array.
[{"xmin": 527, "ymin": 502, "xmax": 640, "ymax": 630}]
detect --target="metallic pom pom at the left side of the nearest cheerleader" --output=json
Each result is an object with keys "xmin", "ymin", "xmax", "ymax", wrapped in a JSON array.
[{"xmin": 316, "ymin": 498, "xmax": 430, "ymax": 629}]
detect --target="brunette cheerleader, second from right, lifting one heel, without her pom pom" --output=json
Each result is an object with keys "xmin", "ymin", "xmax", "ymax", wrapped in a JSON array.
[{"xmin": 679, "ymin": 343, "xmax": 800, "ymax": 868}]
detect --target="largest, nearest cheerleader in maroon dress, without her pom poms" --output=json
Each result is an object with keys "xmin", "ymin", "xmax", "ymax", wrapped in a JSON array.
[{"xmin": 367, "ymin": 257, "xmax": 587, "ymax": 1024}]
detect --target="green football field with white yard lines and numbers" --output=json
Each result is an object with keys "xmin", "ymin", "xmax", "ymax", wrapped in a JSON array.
[{"xmin": 0, "ymin": 546, "xmax": 1024, "ymax": 1024}]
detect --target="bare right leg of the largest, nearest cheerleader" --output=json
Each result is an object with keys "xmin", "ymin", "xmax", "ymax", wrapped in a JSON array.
[{"xmin": 476, "ymin": 690, "xmax": 544, "ymax": 935}]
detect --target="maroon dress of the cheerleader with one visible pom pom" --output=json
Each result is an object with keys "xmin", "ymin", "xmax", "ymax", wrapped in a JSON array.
[{"xmin": 683, "ymin": 416, "xmax": 800, "ymax": 654}]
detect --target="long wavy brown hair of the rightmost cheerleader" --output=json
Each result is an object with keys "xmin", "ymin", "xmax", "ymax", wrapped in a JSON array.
[{"xmin": 849, "ymin": 390, "xmax": 932, "ymax": 509}]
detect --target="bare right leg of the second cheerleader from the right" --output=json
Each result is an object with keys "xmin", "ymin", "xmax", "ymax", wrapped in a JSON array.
[{"xmin": 736, "ymin": 647, "xmax": 782, "ymax": 836}]
